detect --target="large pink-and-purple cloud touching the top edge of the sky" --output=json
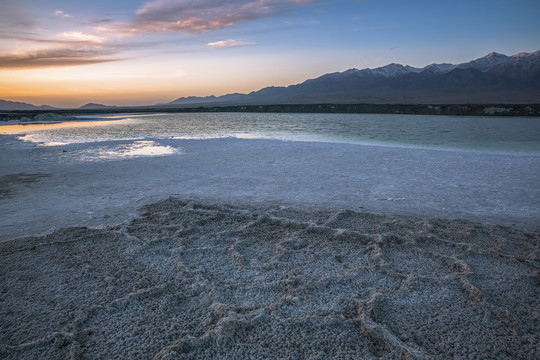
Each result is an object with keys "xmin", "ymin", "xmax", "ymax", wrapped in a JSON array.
[{"xmin": 101, "ymin": 0, "xmax": 313, "ymax": 35}]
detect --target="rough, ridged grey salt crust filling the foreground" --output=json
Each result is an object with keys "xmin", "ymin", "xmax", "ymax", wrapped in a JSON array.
[{"xmin": 0, "ymin": 198, "xmax": 540, "ymax": 359}]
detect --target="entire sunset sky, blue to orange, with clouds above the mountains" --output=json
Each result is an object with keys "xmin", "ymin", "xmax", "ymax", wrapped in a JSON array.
[{"xmin": 0, "ymin": 0, "xmax": 540, "ymax": 107}]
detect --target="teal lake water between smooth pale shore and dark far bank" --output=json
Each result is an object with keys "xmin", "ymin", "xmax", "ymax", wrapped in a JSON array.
[{"xmin": 1, "ymin": 113, "xmax": 540, "ymax": 153}]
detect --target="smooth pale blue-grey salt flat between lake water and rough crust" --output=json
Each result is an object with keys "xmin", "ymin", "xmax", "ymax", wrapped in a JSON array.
[{"xmin": 0, "ymin": 136, "xmax": 540, "ymax": 241}]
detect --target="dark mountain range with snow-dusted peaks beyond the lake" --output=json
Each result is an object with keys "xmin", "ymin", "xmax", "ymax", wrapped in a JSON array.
[{"xmin": 168, "ymin": 51, "xmax": 540, "ymax": 105}]
